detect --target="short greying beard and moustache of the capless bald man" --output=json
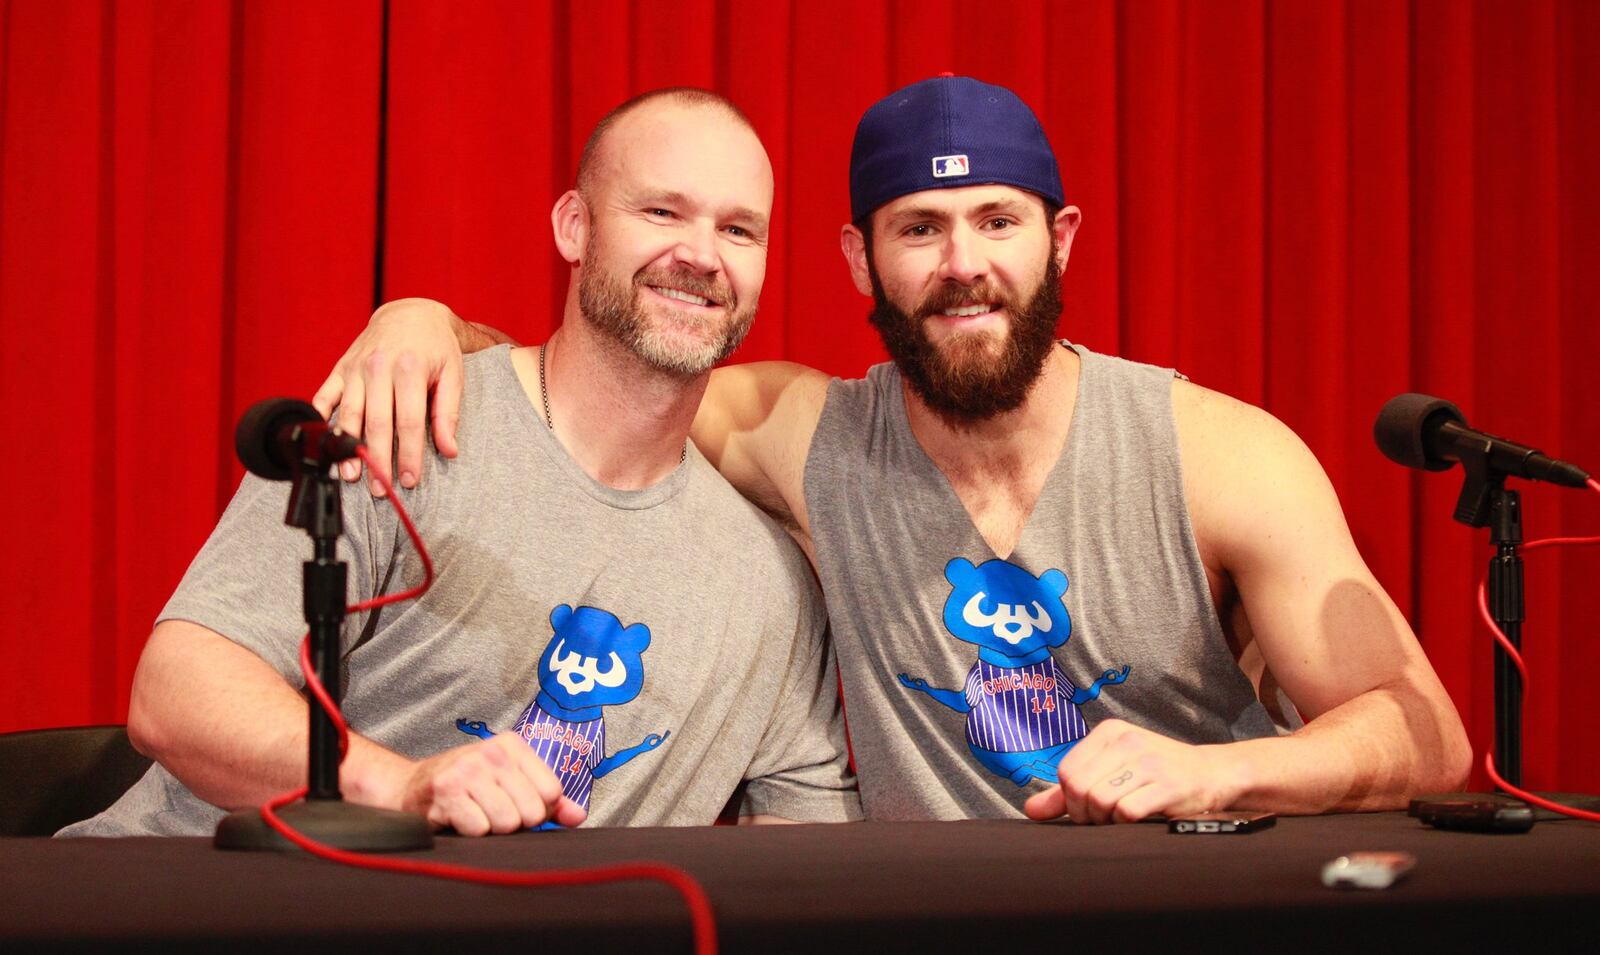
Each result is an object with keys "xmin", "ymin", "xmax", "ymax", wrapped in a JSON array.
[{"xmin": 578, "ymin": 238, "xmax": 755, "ymax": 376}]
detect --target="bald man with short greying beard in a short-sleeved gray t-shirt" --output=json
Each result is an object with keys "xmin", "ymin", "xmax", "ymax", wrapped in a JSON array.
[{"xmin": 64, "ymin": 90, "xmax": 861, "ymax": 835}]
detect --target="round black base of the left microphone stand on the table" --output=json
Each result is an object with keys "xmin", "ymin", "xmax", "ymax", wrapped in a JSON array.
[{"xmin": 211, "ymin": 800, "xmax": 434, "ymax": 853}]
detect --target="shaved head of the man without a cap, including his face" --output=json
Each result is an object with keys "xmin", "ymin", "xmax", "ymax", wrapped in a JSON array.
[{"xmin": 568, "ymin": 88, "xmax": 774, "ymax": 376}]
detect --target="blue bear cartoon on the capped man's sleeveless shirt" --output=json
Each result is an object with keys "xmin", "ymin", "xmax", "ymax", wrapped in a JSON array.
[{"xmin": 899, "ymin": 557, "xmax": 1128, "ymax": 785}]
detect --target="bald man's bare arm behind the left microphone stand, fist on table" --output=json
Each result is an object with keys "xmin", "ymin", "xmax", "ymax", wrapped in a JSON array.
[{"xmin": 128, "ymin": 621, "xmax": 584, "ymax": 835}]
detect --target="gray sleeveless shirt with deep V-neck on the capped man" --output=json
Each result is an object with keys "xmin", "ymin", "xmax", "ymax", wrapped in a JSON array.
[{"xmin": 805, "ymin": 346, "xmax": 1275, "ymax": 819}]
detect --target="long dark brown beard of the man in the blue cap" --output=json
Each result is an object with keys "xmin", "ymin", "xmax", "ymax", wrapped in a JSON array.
[{"xmin": 867, "ymin": 243, "xmax": 1061, "ymax": 429}]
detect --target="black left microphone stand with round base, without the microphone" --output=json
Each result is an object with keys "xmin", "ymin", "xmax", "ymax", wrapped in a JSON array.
[{"xmin": 213, "ymin": 453, "xmax": 434, "ymax": 853}]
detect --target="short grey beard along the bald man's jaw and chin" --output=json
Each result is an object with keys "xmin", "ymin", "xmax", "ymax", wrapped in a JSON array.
[{"xmin": 578, "ymin": 242, "xmax": 755, "ymax": 378}]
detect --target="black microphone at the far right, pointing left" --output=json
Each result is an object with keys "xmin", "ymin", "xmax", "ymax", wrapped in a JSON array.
[{"xmin": 1373, "ymin": 392, "xmax": 1589, "ymax": 488}]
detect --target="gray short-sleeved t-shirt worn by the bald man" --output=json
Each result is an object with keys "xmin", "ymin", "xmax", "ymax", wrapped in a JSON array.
[{"xmin": 62, "ymin": 347, "xmax": 861, "ymax": 835}]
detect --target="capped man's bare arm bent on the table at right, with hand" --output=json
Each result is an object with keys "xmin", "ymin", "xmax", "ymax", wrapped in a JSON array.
[{"xmin": 1027, "ymin": 382, "xmax": 1470, "ymax": 822}]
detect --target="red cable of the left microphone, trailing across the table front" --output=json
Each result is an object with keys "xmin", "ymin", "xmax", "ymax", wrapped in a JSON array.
[{"xmin": 261, "ymin": 445, "xmax": 717, "ymax": 955}]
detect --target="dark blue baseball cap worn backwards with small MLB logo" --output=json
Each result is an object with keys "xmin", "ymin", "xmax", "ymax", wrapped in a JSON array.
[{"xmin": 850, "ymin": 75, "xmax": 1066, "ymax": 222}]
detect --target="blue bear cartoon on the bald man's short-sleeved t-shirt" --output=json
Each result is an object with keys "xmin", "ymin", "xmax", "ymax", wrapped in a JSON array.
[{"xmin": 456, "ymin": 603, "xmax": 672, "ymax": 827}]
